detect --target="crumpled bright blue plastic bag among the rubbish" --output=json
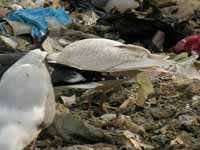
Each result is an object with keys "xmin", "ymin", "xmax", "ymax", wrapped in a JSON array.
[{"xmin": 8, "ymin": 7, "xmax": 72, "ymax": 38}]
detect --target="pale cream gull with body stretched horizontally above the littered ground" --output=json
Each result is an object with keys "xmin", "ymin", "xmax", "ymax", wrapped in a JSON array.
[{"xmin": 49, "ymin": 39, "xmax": 167, "ymax": 72}]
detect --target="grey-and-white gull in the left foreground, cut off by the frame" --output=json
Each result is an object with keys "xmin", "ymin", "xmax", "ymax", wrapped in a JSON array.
[{"xmin": 0, "ymin": 50, "xmax": 55, "ymax": 150}]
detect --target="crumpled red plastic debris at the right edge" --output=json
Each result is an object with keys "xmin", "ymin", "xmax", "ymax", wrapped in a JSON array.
[{"xmin": 171, "ymin": 33, "xmax": 200, "ymax": 55}]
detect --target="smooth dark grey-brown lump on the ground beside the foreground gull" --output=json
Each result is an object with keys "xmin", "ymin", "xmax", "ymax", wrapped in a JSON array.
[{"xmin": 46, "ymin": 113, "xmax": 113, "ymax": 144}]
